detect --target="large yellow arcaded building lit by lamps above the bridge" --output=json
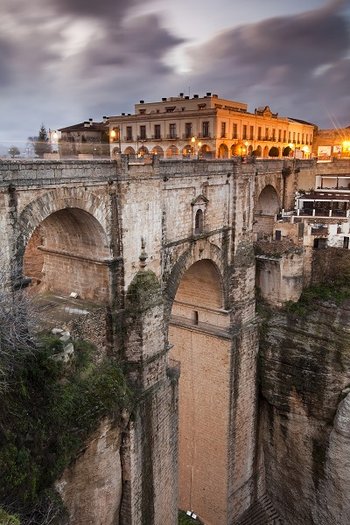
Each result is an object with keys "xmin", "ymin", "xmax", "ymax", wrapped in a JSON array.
[{"xmin": 108, "ymin": 93, "xmax": 314, "ymax": 158}]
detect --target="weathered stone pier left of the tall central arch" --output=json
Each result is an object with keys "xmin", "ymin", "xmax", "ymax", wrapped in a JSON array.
[{"xmin": 120, "ymin": 269, "xmax": 178, "ymax": 525}]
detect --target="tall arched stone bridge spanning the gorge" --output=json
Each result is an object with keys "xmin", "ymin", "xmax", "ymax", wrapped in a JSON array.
[{"xmin": 0, "ymin": 158, "xmax": 314, "ymax": 525}]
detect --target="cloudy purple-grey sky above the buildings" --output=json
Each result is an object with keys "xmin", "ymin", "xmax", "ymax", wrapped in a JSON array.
[{"xmin": 0, "ymin": 0, "xmax": 350, "ymax": 145}]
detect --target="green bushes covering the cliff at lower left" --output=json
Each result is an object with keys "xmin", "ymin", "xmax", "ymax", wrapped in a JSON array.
[{"xmin": 0, "ymin": 335, "xmax": 131, "ymax": 525}]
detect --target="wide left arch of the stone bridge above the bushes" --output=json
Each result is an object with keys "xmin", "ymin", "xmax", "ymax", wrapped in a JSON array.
[{"xmin": 17, "ymin": 191, "xmax": 112, "ymax": 303}]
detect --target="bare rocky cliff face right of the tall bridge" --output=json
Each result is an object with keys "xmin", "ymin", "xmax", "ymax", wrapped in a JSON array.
[{"xmin": 260, "ymin": 301, "xmax": 350, "ymax": 525}]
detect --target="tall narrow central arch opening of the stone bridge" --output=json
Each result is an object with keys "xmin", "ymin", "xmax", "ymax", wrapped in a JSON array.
[{"xmin": 168, "ymin": 243, "xmax": 231, "ymax": 523}]
